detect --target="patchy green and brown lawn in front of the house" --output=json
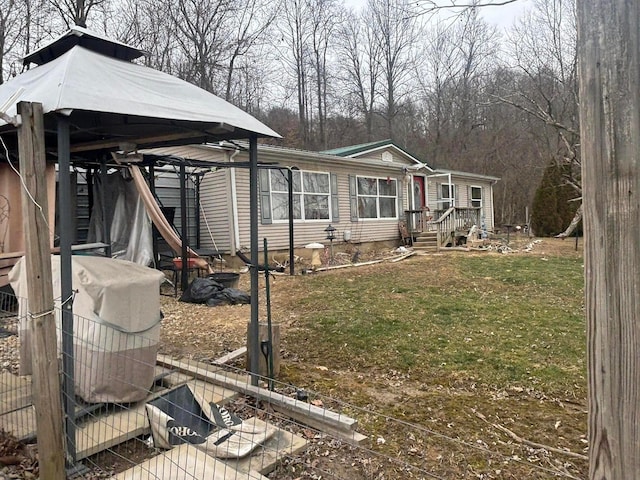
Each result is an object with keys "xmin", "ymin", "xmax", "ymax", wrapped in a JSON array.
[{"xmin": 162, "ymin": 237, "xmax": 587, "ymax": 479}]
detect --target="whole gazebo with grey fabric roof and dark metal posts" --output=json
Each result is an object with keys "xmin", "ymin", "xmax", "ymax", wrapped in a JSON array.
[{"xmin": 0, "ymin": 26, "xmax": 279, "ymax": 468}]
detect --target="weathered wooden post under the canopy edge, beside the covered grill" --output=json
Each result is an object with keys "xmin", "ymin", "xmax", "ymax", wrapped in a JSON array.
[{"xmin": 18, "ymin": 102, "xmax": 66, "ymax": 480}]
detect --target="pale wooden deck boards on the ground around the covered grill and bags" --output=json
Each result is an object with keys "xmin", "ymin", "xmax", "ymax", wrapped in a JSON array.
[{"xmin": 0, "ymin": 367, "xmax": 307, "ymax": 480}]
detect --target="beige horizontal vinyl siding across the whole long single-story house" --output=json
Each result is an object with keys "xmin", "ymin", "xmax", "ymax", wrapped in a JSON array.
[{"xmin": 145, "ymin": 145, "xmax": 493, "ymax": 253}]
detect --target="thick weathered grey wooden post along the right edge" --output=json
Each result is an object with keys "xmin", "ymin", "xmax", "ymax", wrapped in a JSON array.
[{"xmin": 576, "ymin": 0, "xmax": 640, "ymax": 480}]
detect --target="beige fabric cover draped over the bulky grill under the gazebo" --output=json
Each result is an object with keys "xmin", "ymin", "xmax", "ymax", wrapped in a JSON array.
[{"xmin": 9, "ymin": 255, "xmax": 164, "ymax": 403}]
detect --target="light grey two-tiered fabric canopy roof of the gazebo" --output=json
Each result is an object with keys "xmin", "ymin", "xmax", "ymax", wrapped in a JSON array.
[{"xmin": 0, "ymin": 27, "xmax": 279, "ymax": 151}]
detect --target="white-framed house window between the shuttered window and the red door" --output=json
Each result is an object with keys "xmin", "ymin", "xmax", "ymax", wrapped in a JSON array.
[{"xmin": 357, "ymin": 177, "xmax": 398, "ymax": 218}]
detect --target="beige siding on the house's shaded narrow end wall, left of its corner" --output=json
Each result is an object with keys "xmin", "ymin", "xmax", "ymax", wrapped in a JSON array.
[{"xmin": 200, "ymin": 168, "xmax": 233, "ymax": 252}]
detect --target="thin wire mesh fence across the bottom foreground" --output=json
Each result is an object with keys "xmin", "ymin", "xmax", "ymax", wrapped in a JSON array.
[{"xmin": 0, "ymin": 284, "xmax": 584, "ymax": 480}]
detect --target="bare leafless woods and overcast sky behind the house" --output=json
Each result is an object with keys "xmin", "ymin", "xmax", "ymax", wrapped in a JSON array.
[{"xmin": 0, "ymin": 0, "xmax": 580, "ymax": 231}]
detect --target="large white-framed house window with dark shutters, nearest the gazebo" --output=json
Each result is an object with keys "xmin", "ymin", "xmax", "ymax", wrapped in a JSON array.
[{"xmin": 269, "ymin": 170, "xmax": 331, "ymax": 221}]
